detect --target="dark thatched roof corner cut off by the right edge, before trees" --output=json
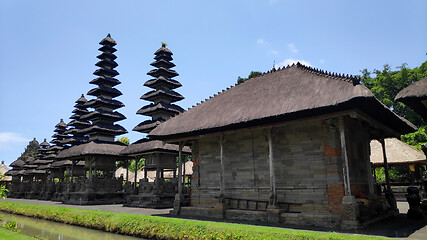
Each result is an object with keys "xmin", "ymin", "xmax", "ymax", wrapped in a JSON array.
[{"xmin": 395, "ymin": 77, "xmax": 427, "ymax": 122}]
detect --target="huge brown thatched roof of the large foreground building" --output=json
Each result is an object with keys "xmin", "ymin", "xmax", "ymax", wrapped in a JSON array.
[{"xmin": 148, "ymin": 64, "xmax": 415, "ymax": 139}]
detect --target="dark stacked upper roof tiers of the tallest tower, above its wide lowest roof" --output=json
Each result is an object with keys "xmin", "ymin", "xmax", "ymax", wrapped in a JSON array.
[{"xmin": 79, "ymin": 34, "xmax": 127, "ymax": 142}]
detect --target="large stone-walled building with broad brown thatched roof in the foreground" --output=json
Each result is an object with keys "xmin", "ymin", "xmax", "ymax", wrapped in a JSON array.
[{"xmin": 148, "ymin": 63, "xmax": 415, "ymax": 228}]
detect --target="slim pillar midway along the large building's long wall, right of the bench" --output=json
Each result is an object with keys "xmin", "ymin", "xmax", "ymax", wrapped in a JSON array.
[{"xmin": 267, "ymin": 128, "xmax": 280, "ymax": 223}]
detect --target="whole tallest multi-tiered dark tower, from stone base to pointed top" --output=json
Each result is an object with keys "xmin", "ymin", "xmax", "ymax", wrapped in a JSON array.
[{"xmin": 57, "ymin": 34, "xmax": 127, "ymax": 204}]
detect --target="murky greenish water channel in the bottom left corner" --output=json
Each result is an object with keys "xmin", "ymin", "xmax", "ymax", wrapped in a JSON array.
[{"xmin": 0, "ymin": 211, "xmax": 145, "ymax": 240}]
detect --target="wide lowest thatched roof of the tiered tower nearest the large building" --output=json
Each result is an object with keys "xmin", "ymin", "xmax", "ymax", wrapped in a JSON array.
[{"xmin": 121, "ymin": 138, "xmax": 191, "ymax": 155}]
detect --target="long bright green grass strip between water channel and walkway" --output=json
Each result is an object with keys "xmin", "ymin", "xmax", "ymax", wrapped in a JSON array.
[{"xmin": 0, "ymin": 202, "xmax": 384, "ymax": 240}]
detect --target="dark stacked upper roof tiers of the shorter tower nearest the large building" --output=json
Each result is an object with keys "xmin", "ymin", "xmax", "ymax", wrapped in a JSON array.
[{"xmin": 133, "ymin": 43, "xmax": 184, "ymax": 133}]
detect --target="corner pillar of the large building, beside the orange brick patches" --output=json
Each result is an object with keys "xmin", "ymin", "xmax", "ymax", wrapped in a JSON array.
[{"xmin": 338, "ymin": 117, "xmax": 360, "ymax": 229}]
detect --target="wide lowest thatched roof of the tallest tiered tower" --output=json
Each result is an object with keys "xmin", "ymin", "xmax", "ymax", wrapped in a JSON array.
[{"xmin": 56, "ymin": 141, "xmax": 126, "ymax": 159}]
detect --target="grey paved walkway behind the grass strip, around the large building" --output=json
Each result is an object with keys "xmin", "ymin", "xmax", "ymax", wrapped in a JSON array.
[{"xmin": 0, "ymin": 198, "xmax": 427, "ymax": 240}]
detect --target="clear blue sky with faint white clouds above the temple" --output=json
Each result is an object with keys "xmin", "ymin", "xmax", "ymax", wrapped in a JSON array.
[{"xmin": 0, "ymin": 0, "xmax": 427, "ymax": 167}]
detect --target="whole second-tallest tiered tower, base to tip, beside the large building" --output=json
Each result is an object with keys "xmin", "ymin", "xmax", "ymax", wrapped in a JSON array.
[{"xmin": 121, "ymin": 43, "xmax": 190, "ymax": 208}]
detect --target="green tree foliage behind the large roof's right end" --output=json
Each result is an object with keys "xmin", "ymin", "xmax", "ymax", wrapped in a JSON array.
[{"xmin": 361, "ymin": 61, "xmax": 427, "ymax": 126}]
